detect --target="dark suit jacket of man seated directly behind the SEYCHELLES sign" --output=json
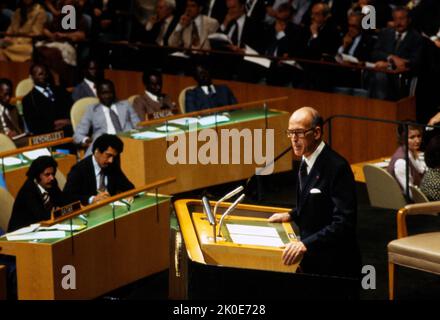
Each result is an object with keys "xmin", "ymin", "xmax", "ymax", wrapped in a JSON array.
[{"xmin": 23, "ymin": 87, "xmax": 73, "ymax": 136}]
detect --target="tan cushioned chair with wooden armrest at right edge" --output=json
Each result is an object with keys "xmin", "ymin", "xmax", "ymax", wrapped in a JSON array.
[{"xmin": 388, "ymin": 201, "xmax": 440, "ymax": 300}]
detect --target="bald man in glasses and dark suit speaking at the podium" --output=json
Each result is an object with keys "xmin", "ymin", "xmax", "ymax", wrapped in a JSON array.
[{"xmin": 269, "ymin": 107, "xmax": 361, "ymax": 278}]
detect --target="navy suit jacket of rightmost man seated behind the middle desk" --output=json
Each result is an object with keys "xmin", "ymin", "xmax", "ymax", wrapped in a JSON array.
[{"xmin": 185, "ymin": 85, "xmax": 237, "ymax": 112}]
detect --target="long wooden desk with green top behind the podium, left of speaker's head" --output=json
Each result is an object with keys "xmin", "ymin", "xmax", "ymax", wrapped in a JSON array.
[{"xmin": 120, "ymin": 108, "xmax": 292, "ymax": 194}]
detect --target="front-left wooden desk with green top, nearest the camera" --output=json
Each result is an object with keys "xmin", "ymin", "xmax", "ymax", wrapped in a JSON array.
[{"xmin": 0, "ymin": 195, "xmax": 170, "ymax": 300}]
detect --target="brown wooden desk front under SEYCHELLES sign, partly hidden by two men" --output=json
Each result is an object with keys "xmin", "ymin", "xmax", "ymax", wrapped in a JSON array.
[{"xmin": 1, "ymin": 154, "xmax": 76, "ymax": 198}]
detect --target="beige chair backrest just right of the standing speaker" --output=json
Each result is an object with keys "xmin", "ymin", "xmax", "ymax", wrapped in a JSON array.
[{"xmin": 364, "ymin": 164, "xmax": 407, "ymax": 210}]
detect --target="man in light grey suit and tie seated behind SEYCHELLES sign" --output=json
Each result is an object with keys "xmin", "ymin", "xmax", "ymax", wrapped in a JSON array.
[{"xmin": 73, "ymin": 79, "xmax": 139, "ymax": 155}]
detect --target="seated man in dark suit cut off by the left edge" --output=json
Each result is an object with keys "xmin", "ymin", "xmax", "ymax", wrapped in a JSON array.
[{"xmin": 0, "ymin": 78, "xmax": 28, "ymax": 147}]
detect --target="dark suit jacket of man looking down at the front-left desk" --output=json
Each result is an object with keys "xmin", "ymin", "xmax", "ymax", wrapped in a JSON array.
[{"xmin": 64, "ymin": 155, "xmax": 134, "ymax": 205}]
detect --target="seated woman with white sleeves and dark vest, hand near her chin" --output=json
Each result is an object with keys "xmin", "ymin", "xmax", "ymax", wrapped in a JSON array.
[{"xmin": 387, "ymin": 125, "xmax": 426, "ymax": 197}]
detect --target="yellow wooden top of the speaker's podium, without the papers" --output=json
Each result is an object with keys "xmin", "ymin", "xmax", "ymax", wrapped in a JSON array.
[{"xmin": 174, "ymin": 200, "xmax": 298, "ymax": 272}]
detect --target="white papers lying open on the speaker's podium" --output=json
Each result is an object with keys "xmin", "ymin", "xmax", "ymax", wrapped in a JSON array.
[{"xmin": 226, "ymin": 223, "xmax": 284, "ymax": 247}]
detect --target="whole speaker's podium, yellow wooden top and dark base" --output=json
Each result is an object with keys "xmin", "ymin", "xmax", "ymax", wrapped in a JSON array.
[{"xmin": 169, "ymin": 199, "xmax": 357, "ymax": 300}]
